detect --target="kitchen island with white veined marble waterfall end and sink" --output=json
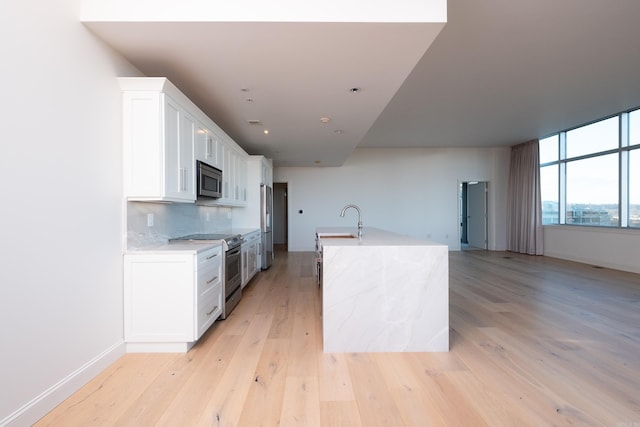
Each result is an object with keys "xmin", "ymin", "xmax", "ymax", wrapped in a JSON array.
[{"xmin": 316, "ymin": 227, "xmax": 449, "ymax": 352}]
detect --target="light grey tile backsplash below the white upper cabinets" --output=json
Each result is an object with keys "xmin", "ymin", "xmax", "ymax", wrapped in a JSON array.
[{"xmin": 127, "ymin": 202, "xmax": 232, "ymax": 249}]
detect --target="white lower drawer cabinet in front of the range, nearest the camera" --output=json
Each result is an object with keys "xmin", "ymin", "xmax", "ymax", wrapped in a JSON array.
[{"xmin": 124, "ymin": 246, "xmax": 222, "ymax": 352}]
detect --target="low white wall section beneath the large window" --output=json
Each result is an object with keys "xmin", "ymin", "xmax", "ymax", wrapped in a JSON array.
[{"xmin": 544, "ymin": 226, "xmax": 640, "ymax": 273}]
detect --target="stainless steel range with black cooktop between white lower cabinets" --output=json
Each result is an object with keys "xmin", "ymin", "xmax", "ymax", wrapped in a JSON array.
[{"xmin": 171, "ymin": 234, "xmax": 242, "ymax": 319}]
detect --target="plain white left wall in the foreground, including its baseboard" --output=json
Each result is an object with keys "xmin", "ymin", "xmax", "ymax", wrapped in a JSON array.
[{"xmin": 0, "ymin": 0, "xmax": 139, "ymax": 425}]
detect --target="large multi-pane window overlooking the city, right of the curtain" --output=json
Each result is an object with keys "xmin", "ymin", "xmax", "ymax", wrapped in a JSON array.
[{"xmin": 540, "ymin": 110, "xmax": 640, "ymax": 228}]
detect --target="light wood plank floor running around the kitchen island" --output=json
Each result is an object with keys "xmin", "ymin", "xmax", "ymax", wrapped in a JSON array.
[{"xmin": 37, "ymin": 251, "xmax": 640, "ymax": 427}]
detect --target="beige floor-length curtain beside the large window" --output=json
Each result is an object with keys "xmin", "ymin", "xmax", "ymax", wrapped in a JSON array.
[{"xmin": 507, "ymin": 139, "xmax": 543, "ymax": 255}]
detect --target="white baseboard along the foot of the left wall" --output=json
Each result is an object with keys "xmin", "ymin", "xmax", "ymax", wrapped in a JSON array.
[{"xmin": 0, "ymin": 341, "xmax": 126, "ymax": 427}]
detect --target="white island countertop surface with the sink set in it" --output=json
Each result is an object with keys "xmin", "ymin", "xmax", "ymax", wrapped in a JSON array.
[{"xmin": 316, "ymin": 227, "xmax": 445, "ymax": 246}]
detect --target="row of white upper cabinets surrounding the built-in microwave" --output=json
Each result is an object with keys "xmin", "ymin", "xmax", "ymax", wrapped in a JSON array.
[{"xmin": 118, "ymin": 77, "xmax": 248, "ymax": 207}]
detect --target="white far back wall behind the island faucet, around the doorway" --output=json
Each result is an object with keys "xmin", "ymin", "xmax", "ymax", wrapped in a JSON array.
[{"xmin": 274, "ymin": 147, "xmax": 510, "ymax": 251}]
